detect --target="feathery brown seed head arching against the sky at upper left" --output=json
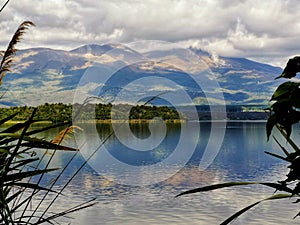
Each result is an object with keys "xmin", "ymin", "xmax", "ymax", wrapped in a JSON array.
[{"xmin": 0, "ymin": 21, "xmax": 35, "ymax": 85}]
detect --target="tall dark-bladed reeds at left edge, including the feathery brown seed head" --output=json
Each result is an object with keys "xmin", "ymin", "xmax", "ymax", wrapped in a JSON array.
[{"xmin": 0, "ymin": 21, "xmax": 95, "ymax": 224}]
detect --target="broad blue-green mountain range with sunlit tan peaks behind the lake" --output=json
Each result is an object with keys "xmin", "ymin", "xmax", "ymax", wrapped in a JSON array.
[{"xmin": 2, "ymin": 44, "xmax": 282, "ymax": 105}]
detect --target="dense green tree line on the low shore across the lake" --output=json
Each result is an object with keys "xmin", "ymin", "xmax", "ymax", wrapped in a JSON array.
[{"xmin": 0, "ymin": 103, "xmax": 180, "ymax": 123}]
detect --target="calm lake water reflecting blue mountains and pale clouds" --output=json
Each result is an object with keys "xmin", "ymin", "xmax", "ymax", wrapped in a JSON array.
[{"xmin": 24, "ymin": 122, "xmax": 300, "ymax": 225}]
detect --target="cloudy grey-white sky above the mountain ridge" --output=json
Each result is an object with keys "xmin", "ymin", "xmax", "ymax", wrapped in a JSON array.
[{"xmin": 0, "ymin": 0, "xmax": 300, "ymax": 67}]
